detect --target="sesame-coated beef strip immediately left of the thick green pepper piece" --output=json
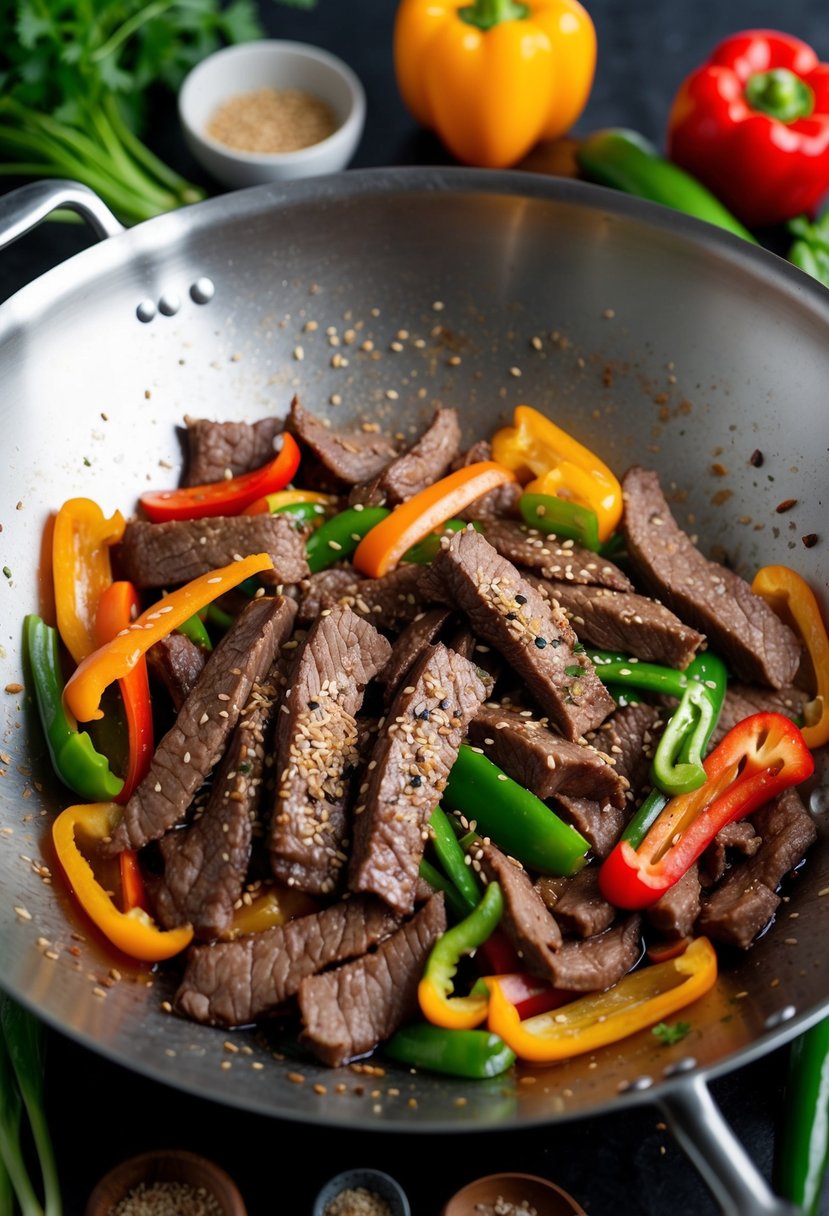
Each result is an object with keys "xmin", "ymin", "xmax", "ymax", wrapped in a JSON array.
[{"xmin": 349, "ymin": 643, "xmax": 486, "ymax": 913}]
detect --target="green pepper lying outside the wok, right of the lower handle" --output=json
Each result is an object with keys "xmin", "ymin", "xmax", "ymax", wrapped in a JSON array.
[{"xmin": 774, "ymin": 1018, "xmax": 829, "ymax": 1216}]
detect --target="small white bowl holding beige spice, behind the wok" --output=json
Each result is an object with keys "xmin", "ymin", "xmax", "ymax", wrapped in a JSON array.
[{"xmin": 179, "ymin": 39, "xmax": 366, "ymax": 188}]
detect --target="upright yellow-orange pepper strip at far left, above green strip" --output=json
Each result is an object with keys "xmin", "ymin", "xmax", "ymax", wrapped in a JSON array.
[{"xmin": 52, "ymin": 499, "xmax": 125, "ymax": 663}]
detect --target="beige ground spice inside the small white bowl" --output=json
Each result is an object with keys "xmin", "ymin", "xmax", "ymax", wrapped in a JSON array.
[{"xmin": 207, "ymin": 89, "xmax": 337, "ymax": 153}]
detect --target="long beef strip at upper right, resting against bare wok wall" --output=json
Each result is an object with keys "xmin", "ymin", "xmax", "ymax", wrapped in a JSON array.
[{"xmin": 622, "ymin": 466, "xmax": 800, "ymax": 688}]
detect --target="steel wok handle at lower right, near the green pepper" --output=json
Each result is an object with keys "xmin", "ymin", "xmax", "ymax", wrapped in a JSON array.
[{"xmin": 659, "ymin": 1076, "xmax": 799, "ymax": 1216}]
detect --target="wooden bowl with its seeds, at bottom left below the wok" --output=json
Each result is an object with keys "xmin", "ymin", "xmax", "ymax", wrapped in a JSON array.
[{"xmin": 84, "ymin": 1149, "xmax": 247, "ymax": 1216}]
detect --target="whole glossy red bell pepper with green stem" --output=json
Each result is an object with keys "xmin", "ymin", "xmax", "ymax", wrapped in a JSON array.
[{"xmin": 667, "ymin": 29, "xmax": 829, "ymax": 227}]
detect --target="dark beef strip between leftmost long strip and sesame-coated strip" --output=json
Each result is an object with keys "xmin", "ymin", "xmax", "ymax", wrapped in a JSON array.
[{"xmin": 153, "ymin": 668, "xmax": 277, "ymax": 941}]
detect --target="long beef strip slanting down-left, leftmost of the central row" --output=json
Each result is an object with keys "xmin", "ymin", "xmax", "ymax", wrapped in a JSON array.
[{"xmin": 106, "ymin": 596, "xmax": 297, "ymax": 854}]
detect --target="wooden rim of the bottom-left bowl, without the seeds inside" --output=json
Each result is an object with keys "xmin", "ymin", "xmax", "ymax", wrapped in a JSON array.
[{"xmin": 84, "ymin": 1149, "xmax": 247, "ymax": 1216}]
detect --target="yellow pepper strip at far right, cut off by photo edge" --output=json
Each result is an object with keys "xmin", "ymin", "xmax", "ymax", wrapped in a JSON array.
[{"xmin": 751, "ymin": 565, "xmax": 829, "ymax": 748}]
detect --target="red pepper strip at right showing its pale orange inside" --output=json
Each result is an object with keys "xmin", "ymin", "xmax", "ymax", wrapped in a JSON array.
[{"xmin": 598, "ymin": 713, "xmax": 814, "ymax": 908}]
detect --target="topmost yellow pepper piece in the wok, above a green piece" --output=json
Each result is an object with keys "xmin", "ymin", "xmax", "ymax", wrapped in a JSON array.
[{"xmin": 492, "ymin": 405, "xmax": 622, "ymax": 541}]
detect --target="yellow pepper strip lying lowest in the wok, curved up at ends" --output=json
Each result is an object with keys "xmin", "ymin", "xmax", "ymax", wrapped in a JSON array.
[{"xmin": 486, "ymin": 938, "xmax": 717, "ymax": 1064}]
